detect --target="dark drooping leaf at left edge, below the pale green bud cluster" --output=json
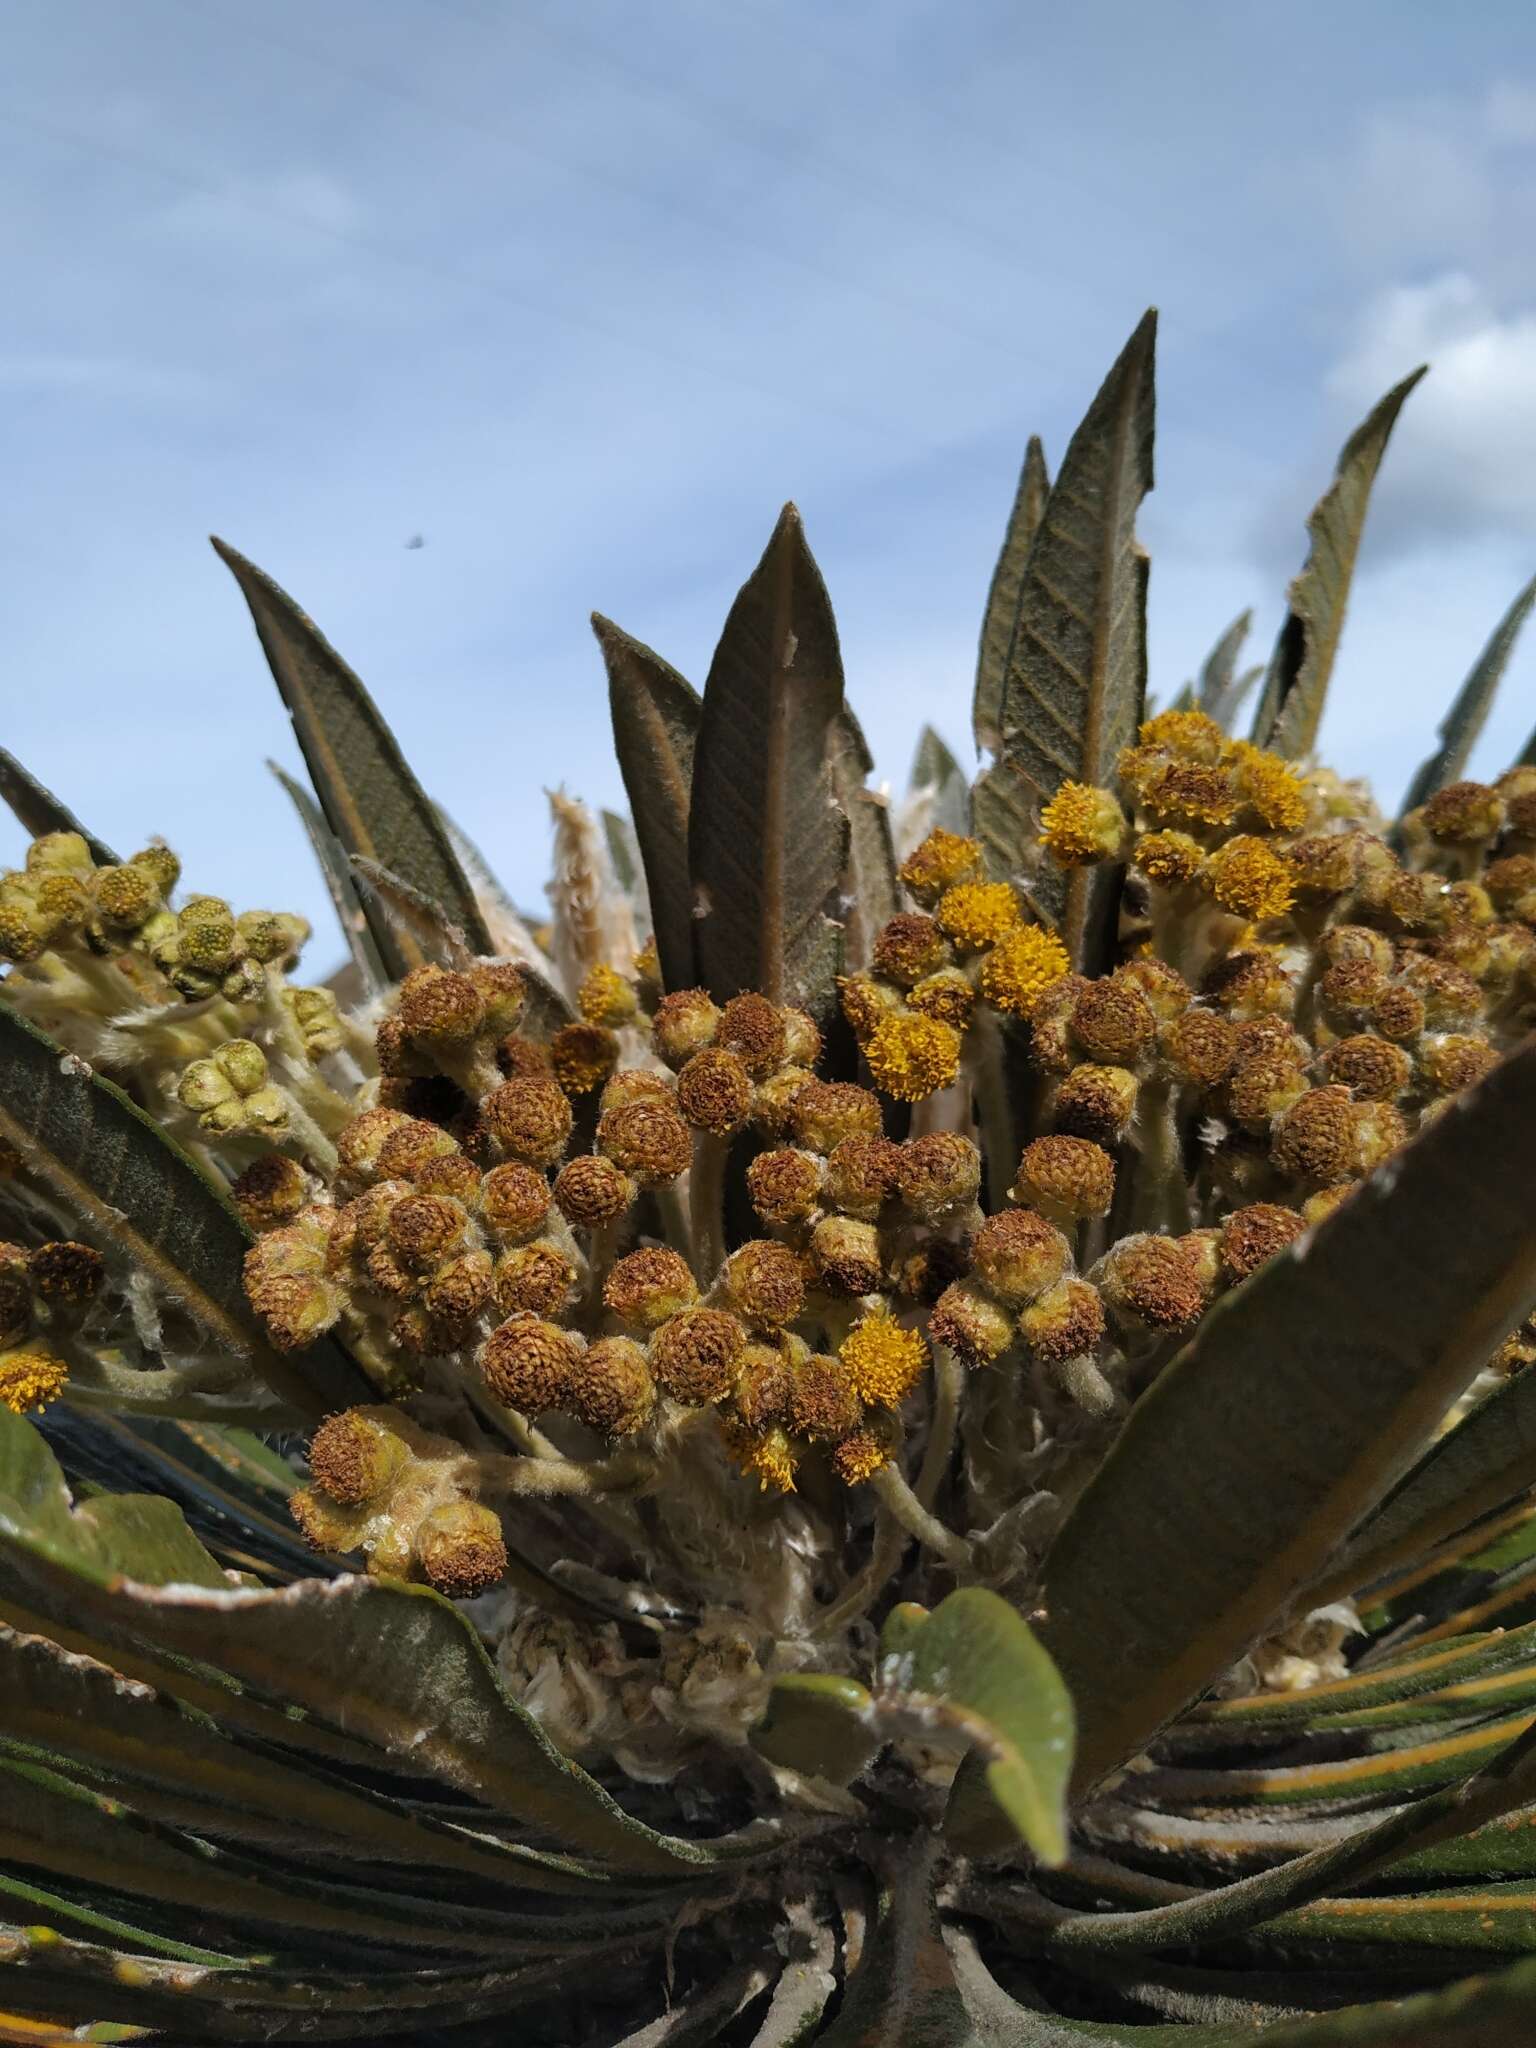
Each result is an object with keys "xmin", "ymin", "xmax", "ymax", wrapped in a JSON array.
[{"xmin": 0, "ymin": 1004, "xmax": 367, "ymax": 1417}]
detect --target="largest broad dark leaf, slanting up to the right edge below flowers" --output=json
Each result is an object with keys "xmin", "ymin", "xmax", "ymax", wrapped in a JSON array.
[{"xmin": 1040, "ymin": 1044, "xmax": 1536, "ymax": 1784}]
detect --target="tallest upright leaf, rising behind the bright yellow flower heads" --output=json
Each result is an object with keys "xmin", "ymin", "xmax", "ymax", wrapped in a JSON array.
[{"xmin": 999, "ymin": 313, "xmax": 1157, "ymax": 973}]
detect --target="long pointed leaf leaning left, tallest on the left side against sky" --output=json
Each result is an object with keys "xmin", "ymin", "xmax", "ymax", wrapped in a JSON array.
[{"xmin": 213, "ymin": 539, "xmax": 492, "ymax": 977}]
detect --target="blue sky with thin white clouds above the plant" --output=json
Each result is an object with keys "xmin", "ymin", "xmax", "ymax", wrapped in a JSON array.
[{"xmin": 0, "ymin": 0, "xmax": 1536, "ymax": 969}]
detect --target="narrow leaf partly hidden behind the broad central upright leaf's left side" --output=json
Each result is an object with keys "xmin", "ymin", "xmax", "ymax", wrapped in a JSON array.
[{"xmin": 592, "ymin": 612, "xmax": 700, "ymax": 989}]
